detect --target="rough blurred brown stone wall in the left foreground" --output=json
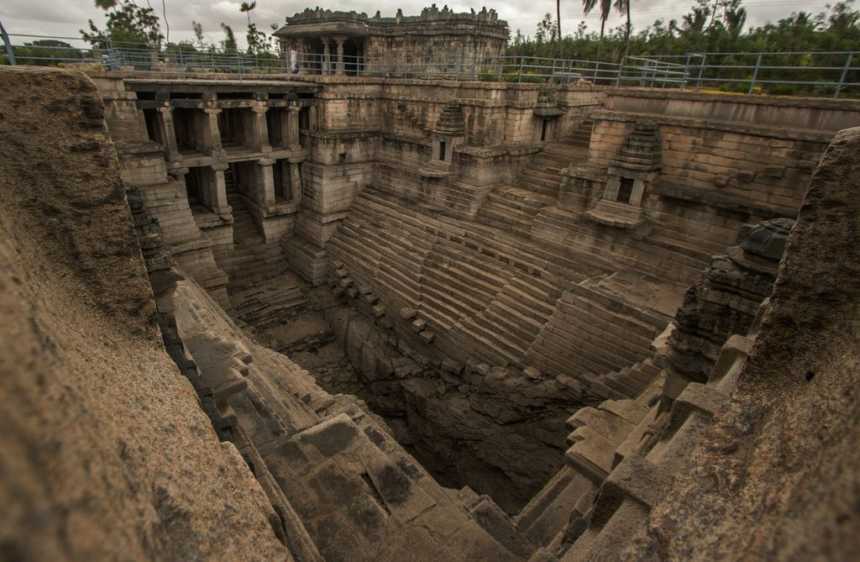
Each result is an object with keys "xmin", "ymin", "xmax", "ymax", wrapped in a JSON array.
[{"xmin": 0, "ymin": 67, "xmax": 290, "ymax": 562}]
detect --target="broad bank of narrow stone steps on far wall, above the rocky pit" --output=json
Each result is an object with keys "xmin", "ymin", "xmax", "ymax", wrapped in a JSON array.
[{"xmin": 328, "ymin": 188, "xmax": 666, "ymax": 376}]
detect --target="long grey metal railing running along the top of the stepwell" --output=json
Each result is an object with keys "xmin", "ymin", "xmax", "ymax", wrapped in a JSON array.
[{"xmin": 5, "ymin": 35, "xmax": 860, "ymax": 97}]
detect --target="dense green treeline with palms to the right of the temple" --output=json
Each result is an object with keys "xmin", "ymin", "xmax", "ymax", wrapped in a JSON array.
[{"xmin": 507, "ymin": 0, "xmax": 860, "ymax": 97}]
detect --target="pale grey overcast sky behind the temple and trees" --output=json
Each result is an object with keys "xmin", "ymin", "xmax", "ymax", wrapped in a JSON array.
[{"xmin": 0, "ymin": 0, "xmax": 833, "ymax": 47}]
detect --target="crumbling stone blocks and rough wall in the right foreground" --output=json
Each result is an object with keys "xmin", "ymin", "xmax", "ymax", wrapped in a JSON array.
[{"xmin": 517, "ymin": 129, "xmax": 860, "ymax": 562}]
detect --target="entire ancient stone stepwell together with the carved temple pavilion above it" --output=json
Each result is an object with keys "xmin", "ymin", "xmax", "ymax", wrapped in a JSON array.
[{"xmin": 0, "ymin": 4, "xmax": 860, "ymax": 562}]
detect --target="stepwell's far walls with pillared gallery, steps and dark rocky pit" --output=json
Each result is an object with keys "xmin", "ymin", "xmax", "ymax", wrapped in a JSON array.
[{"xmin": 84, "ymin": 62, "xmax": 858, "ymax": 513}]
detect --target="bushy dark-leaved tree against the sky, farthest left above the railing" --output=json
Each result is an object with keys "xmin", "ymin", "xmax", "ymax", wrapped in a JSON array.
[{"xmin": 80, "ymin": 0, "xmax": 164, "ymax": 49}]
